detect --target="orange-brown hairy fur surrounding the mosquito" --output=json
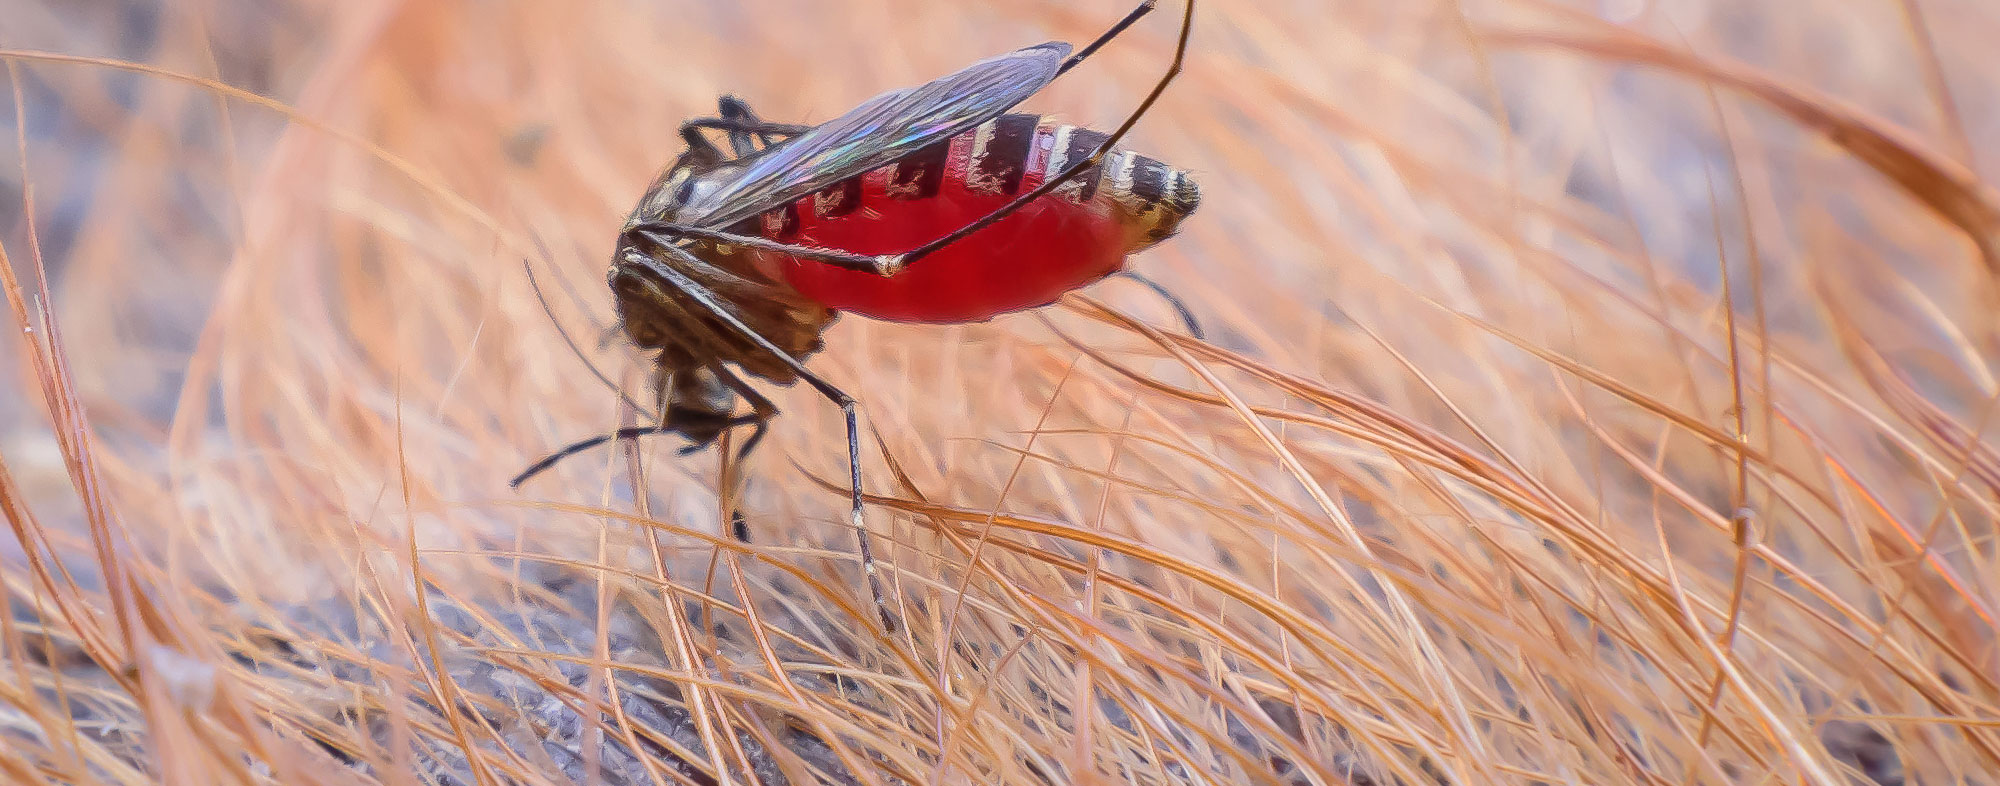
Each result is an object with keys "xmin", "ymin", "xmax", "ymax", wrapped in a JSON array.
[{"xmin": 0, "ymin": 0, "xmax": 2000, "ymax": 784}]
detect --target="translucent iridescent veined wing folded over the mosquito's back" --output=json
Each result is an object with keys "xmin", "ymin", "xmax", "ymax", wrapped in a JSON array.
[{"xmin": 676, "ymin": 42, "xmax": 1070, "ymax": 228}]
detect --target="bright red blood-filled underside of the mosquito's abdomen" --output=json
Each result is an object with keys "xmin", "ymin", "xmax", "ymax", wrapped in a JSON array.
[{"xmin": 774, "ymin": 168, "xmax": 1126, "ymax": 322}]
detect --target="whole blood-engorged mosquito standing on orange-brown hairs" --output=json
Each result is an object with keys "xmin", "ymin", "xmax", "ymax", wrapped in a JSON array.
[{"xmin": 510, "ymin": 0, "xmax": 1200, "ymax": 630}]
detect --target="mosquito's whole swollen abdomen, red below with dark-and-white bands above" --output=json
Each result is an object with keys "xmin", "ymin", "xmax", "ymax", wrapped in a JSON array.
[{"xmin": 760, "ymin": 114, "xmax": 1200, "ymax": 322}]
